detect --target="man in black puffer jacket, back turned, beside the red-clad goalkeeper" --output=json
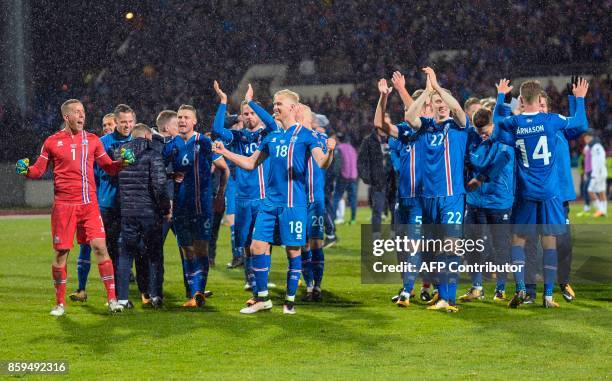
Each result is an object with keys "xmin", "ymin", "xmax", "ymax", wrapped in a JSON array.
[{"xmin": 117, "ymin": 125, "xmax": 171, "ymax": 308}]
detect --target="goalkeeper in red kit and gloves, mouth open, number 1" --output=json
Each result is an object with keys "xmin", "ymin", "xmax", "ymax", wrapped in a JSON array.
[{"xmin": 16, "ymin": 99, "xmax": 135, "ymax": 316}]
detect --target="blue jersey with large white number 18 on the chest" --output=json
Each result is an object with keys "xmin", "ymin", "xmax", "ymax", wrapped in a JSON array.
[{"xmin": 257, "ymin": 124, "xmax": 321, "ymax": 208}]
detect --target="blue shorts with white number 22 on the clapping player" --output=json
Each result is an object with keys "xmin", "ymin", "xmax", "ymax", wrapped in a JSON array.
[{"xmin": 421, "ymin": 194, "xmax": 465, "ymax": 237}]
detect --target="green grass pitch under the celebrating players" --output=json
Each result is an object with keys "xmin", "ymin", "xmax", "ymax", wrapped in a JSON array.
[{"xmin": 0, "ymin": 205, "xmax": 612, "ymax": 380}]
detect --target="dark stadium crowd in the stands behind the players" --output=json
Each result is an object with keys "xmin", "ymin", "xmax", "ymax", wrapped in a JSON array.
[{"xmin": 0, "ymin": 0, "xmax": 612, "ymax": 159}]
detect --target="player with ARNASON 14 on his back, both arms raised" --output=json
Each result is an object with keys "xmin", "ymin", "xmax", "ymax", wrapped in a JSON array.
[{"xmin": 492, "ymin": 79, "xmax": 589, "ymax": 308}]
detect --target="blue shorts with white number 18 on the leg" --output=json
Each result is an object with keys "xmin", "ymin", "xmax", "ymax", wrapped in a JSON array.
[{"xmin": 253, "ymin": 204, "xmax": 308, "ymax": 246}]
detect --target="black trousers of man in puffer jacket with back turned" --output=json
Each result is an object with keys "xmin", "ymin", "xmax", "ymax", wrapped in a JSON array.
[{"xmin": 116, "ymin": 217, "xmax": 164, "ymax": 300}]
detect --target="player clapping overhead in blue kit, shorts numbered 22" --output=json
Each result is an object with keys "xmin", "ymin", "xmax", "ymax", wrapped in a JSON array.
[{"xmin": 398, "ymin": 67, "xmax": 469, "ymax": 312}]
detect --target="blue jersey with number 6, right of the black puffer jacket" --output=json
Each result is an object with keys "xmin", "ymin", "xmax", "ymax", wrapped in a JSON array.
[{"xmin": 163, "ymin": 132, "xmax": 221, "ymax": 215}]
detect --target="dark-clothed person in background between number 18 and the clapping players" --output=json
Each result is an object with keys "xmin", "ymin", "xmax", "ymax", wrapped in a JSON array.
[{"xmin": 357, "ymin": 129, "xmax": 393, "ymax": 239}]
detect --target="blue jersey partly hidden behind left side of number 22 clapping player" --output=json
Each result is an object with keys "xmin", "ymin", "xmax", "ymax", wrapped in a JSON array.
[{"xmin": 389, "ymin": 122, "xmax": 423, "ymax": 198}]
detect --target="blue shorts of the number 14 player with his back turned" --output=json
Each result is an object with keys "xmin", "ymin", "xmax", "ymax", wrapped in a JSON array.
[{"xmin": 512, "ymin": 197, "xmax": 567, "ymax": 236}]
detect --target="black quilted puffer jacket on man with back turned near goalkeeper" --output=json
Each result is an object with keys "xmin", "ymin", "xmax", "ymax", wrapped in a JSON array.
[{"xmin": 119, "ymin": 138, "xmax": 170, "ymax": 217}]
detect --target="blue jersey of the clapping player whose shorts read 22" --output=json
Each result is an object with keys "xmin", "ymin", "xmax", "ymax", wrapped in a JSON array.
[{"xmin": 415, "ymin": 117, "xmax": 470, "ymax": 197}]
